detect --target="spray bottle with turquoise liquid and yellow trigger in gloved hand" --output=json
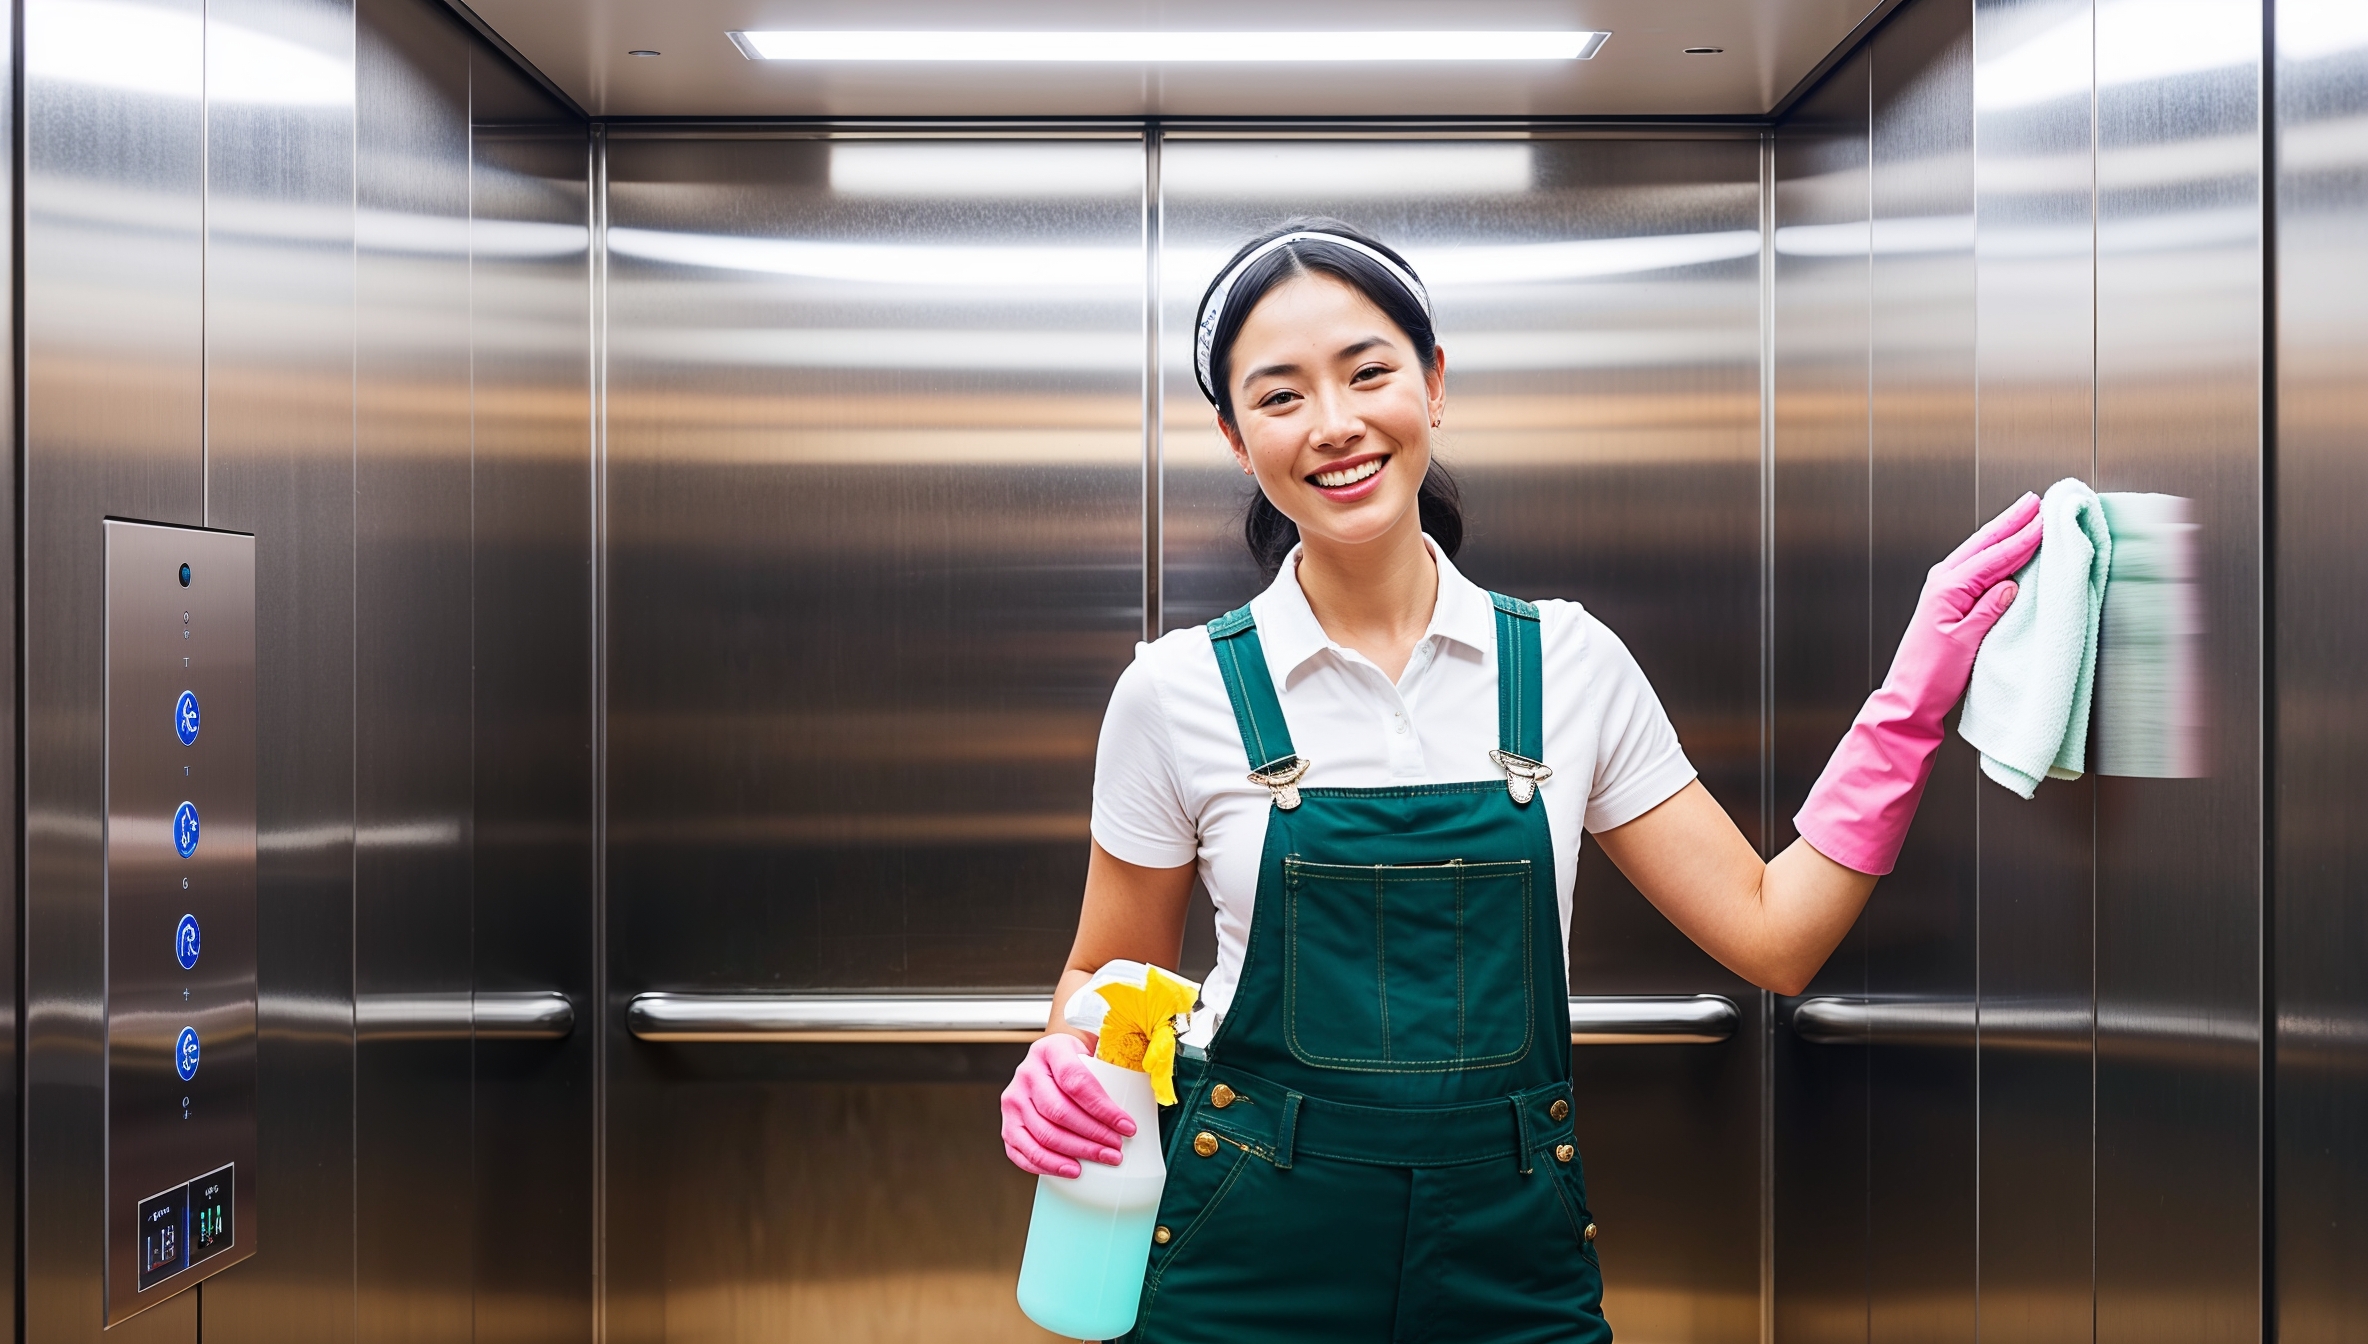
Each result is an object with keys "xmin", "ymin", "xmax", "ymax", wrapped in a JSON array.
[{"xmin": 1021, "ymin": 961, "xmax": 1201, "ymax": 1339}]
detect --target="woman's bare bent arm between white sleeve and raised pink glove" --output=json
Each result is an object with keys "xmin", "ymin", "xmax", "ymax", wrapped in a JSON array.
[{"xmin": 1596, "ymin": 781, "xmax": 1875, "ymax": 994}]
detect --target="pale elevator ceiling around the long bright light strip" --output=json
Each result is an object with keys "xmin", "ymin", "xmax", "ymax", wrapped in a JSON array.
[{"xmin": 452, "ymin": 0, "xmax": 1880, "ymax": 118}]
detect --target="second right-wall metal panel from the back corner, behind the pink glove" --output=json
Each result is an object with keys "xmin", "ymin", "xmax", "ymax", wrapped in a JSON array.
[{"xmin": 1859, "ymin": 0, "xmax": 1982, "ymax": 1344}]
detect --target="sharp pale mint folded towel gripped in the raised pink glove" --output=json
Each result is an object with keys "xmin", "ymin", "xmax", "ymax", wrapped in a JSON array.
[{"xmin": 1956, "ymin": 478, "xmax": 2112, "ymax": 797}]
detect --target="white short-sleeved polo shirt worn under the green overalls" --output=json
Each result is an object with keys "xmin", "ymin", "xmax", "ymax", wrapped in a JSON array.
[{"xmin": 1094, "ymin": 537, "xmax": 1693, "ymax": 1043}]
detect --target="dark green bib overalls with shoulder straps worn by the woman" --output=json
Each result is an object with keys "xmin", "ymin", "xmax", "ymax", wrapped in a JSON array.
[{"xmin": 1130, "ymin": 594, "xmax": 1610, "ymax": 1344}]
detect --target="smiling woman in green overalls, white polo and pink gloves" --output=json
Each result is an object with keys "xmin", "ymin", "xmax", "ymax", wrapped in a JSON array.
[{"xmin": 1004, "ymin": 220, "xmax": 2039, "ymax": 1344}]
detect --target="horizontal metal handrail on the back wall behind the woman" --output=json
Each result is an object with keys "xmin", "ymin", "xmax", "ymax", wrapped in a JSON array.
[{"xmin": 625, "ymin": 994, "xmax": 1743, "ymax": 1046}]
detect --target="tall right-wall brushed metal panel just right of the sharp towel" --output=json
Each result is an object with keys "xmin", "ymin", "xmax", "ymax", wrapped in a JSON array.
[{"xmin": 2096, "ymin": 0, "xmax": 2264, "ymax": 1344}]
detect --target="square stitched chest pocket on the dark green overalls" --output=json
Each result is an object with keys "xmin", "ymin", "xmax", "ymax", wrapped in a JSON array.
[{"xmin": 1283, "ymin": 859, "xmax": 1537, "ymax": 1074}]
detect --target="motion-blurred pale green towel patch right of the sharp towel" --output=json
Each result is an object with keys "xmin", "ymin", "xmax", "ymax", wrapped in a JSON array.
[{"xmin": 2096, "ymin": 495, "xmax": 2205, "ymax": 778}]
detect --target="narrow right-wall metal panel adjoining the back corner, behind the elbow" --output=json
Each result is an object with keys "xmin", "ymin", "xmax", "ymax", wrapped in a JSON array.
[{"xmin": 1767, "ymin": 50, "xmax": 1878, "ymax": 1344}]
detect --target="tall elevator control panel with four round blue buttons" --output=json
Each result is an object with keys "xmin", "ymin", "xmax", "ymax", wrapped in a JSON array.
[{"xmin": 107, "ymin": 518, "xmax": 256, "ymax": 1325}]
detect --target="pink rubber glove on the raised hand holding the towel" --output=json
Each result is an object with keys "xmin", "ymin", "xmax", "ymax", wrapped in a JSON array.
[{"xmin": 1793, "ymin": 492, "xmax": 2039, "ymax": 875}]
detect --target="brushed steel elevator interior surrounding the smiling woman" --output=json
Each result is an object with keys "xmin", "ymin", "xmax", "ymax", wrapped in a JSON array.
[{"xmin": 0, "ymin": 0, "xmax": 2368, "ymax": 1344}]
